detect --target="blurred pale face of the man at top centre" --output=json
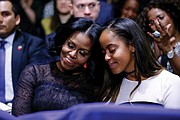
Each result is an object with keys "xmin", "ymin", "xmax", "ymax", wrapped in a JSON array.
[{"xmin": 70, "ymin": 0, "xmax": 100, "ymax": 21}]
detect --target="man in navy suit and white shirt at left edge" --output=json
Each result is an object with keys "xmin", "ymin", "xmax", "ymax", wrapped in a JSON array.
[{"xmin": 0, "ymin": 0, "xmax": 45, "ymax": 103}]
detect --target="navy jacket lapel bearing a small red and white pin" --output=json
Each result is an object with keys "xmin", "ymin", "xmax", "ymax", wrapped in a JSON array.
[{"xmin": 12, "ymin": 31, "xmax": 25, "ymax": 84}]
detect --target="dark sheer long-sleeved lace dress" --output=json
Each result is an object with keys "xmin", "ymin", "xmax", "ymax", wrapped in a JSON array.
[{"xmin": 12, "ymin": 62, "xmax": 97, "ymax": 116}]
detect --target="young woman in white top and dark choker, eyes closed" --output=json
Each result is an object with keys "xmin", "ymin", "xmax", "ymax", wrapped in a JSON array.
[{"xmin": 99, "ymin": 18, "xmax": 180, "ymax": 109}]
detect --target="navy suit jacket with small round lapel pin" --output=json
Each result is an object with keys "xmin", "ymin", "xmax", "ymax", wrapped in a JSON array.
[{"xmin": 12, "ymin": 30, "xmax": 46, "ymax": 89}]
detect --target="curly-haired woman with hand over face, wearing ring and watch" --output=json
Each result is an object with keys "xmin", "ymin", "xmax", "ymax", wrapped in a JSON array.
[{"xmin": 137, "ymin": 0, "xmax": 180, "ymax": 75}]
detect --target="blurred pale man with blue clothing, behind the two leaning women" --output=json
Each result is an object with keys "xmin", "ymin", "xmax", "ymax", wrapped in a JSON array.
[{"xmin": 70, "ymin": 0, "xmax": 113, "ymax": 25}]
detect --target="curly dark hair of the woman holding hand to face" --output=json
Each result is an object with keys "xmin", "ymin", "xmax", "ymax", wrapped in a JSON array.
[{"xmin": 136, "ymin": 0, "xmax": 180, "ymax": 40}]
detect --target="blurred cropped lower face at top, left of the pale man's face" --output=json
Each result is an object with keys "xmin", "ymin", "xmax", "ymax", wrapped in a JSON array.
[{"xmin": 56, "ymin": 0, "xmax": 71, "ymax": 15}]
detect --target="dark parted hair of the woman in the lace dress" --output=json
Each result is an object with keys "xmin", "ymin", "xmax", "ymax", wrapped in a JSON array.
[{"xmin": 49, "ymin": 18, "xmax": 101, "ymax": 83}]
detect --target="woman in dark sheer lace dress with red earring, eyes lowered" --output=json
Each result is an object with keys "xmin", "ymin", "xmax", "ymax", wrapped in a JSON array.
[{"xmin": 12, "ymin": 18, "xmax": 100, "ymax": 116}]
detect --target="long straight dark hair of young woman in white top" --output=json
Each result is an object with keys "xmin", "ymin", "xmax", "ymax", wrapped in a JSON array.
[{"xmin": 101, "ymin": 18, "xmax": 163, "ymax": 102}]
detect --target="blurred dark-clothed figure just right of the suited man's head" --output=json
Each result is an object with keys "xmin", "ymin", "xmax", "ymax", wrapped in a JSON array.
[{"xmin": 16, "ymin": 0, "xmax": 45, "ymax": 38}]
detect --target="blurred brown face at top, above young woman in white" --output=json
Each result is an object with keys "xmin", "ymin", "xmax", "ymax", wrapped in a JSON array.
[{"xmin": 121, "ymin": 0, "xmax": 140, "ymax": 20}]
